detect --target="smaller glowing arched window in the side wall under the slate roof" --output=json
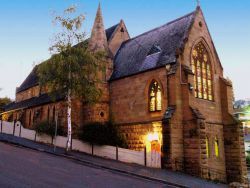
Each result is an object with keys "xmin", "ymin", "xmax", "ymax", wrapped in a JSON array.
[{"xmin": 149, "ymin": 81, "xmax": 162, "ymax": 112}]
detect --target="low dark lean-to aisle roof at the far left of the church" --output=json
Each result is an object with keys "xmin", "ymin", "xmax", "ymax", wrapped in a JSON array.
[{"xmin": 4, "ymin": 94, "xmax": 65, "ymax": 111}]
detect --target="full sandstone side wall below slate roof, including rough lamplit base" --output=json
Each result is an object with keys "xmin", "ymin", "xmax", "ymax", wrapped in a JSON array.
[{"xmin": 110, "ymin": 68, "xmax": 167, "ymax": 150}]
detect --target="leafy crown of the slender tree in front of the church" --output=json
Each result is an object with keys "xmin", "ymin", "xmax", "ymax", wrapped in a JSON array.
[{"xmin": 37, "ymin": 6, "xmax": 105, "ymax": 103}]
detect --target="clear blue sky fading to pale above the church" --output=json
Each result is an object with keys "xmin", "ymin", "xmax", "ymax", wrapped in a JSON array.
[{"xmin": 0, "ymin": 0, "xmax": 250, "ymax": 99}]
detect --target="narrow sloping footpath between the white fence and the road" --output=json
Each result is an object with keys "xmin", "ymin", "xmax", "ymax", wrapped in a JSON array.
[{"xmin": 0, "ymin": 133, "xmax": 228, "ymax": 188}]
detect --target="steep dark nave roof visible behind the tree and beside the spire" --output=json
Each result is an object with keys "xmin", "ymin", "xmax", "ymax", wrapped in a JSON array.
[{"xmin": 16, "ymin": 24, "xmax": 119, "ymax": 93}]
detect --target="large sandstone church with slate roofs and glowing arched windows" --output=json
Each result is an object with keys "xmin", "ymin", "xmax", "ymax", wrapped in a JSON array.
[{"xmin": 3, "ymin": 6, "xmax": 247, "ymax": 182}]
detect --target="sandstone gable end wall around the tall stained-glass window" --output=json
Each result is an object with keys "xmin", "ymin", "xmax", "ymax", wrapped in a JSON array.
[{"xmin": 179, "ymin": 8, "xmax": 231, "ymax": 181}]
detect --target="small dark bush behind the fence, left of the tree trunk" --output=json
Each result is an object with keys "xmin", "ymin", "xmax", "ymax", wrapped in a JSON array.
[{"xmin": 34, "ymin": 121, "xmax": 65, "ymax": 138}]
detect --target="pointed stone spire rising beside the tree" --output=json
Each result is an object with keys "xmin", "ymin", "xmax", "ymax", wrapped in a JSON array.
[{"xmin": 89, "ymin": 3, "xmax": 108, "ymax": 52}]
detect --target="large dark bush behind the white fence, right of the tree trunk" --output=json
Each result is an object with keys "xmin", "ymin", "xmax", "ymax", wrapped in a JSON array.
[{"xmin": 79, "ymin": 122, "xmax": 127, "ymax": 148}]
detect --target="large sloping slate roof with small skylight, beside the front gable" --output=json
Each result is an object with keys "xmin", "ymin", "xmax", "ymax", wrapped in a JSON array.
[{"xmin": 111, "ymin": 11, "xmax": 196, "ymax": 81}]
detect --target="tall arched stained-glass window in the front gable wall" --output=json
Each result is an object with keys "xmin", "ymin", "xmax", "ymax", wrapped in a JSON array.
[{"xmin": 191, "ymin": 42, "xmax": 213, "ymax": 101}]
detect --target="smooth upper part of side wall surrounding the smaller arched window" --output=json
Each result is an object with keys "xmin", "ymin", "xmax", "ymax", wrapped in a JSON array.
[{"xmin": 110, "ymin": 68, "xmax": 167, "ymax": 124}]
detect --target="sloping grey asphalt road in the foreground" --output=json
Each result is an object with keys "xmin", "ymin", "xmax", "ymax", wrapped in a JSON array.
[{"xmin": 0, "ymin": 142, "xmax": 174, "ymax": 188}]
